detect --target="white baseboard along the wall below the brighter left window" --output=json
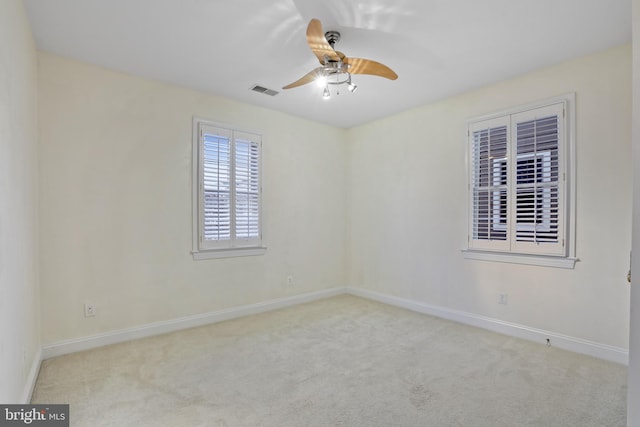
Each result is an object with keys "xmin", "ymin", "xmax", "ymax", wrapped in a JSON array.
[{"xmin": 42, "ymin": 288, "xmax": 346, "ymax": 359}]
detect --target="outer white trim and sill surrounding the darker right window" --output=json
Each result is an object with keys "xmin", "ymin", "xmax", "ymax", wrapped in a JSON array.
[{"xmin": 462, "ymin": 92, "xmax": 579, "ymax": 269}]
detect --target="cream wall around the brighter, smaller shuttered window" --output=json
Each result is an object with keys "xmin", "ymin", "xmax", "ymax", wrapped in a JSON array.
[{"xmin": 39, "ymin": 53, "xmax": 346, "ymax": 344}]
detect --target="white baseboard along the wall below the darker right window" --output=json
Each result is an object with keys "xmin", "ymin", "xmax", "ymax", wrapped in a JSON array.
[{"xmin": 347, "ymin": 287, "xmax": 629, "ymax": 365}]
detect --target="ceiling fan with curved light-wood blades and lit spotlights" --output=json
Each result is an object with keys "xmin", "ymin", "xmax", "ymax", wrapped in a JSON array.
[{"xmin": 282, "ymin": 19, "xmax": 398, "ymax": 98}]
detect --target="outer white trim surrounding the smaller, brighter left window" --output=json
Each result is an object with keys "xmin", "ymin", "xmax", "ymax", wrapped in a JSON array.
[{"xmin": 191, "ymin": 116, "xmax": 267, "ymax": 260}]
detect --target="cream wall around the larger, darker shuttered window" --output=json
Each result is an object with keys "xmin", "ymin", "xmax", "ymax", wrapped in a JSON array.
[{"xmin": 348, "ymin": 46, "xmax": 632, "ymax": 349}]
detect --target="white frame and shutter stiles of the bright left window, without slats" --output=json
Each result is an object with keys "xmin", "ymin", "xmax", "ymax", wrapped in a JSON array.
[{"xmin": 191, "ymin": 117, "xmax": 266, "ymax": 260}]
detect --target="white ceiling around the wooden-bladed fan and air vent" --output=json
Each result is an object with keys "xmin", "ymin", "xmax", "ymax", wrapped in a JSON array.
[{"xmin": 24, "ymin": 0, "xmax": 631, "ymax": 128}]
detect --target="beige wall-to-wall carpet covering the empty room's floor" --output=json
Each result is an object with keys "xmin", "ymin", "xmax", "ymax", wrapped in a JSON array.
[{"xmin": 33, "ymin": 295, "xmax": 627, "ymax": 427}]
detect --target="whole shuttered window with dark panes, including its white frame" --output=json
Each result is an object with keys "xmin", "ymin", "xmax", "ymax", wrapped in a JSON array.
[{"xmin": 467, "ymin": 96, "xmax": 575, "ymax": 267}]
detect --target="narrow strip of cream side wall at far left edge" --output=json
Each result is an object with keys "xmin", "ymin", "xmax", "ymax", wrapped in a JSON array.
[{"xmin": 0, "ymin": 0, "xmax": 40, "ymax": 403}]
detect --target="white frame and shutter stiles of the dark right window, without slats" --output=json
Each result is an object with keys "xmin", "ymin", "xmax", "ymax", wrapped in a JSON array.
[{"xmin": 462, "ymin": 93, "xmax": 577, "ymax": 268}]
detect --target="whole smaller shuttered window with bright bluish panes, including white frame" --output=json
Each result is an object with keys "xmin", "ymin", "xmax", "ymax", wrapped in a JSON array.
[{"xmin": 193, "ymin": 119, "xmax": 264, "ymax": 259}]
